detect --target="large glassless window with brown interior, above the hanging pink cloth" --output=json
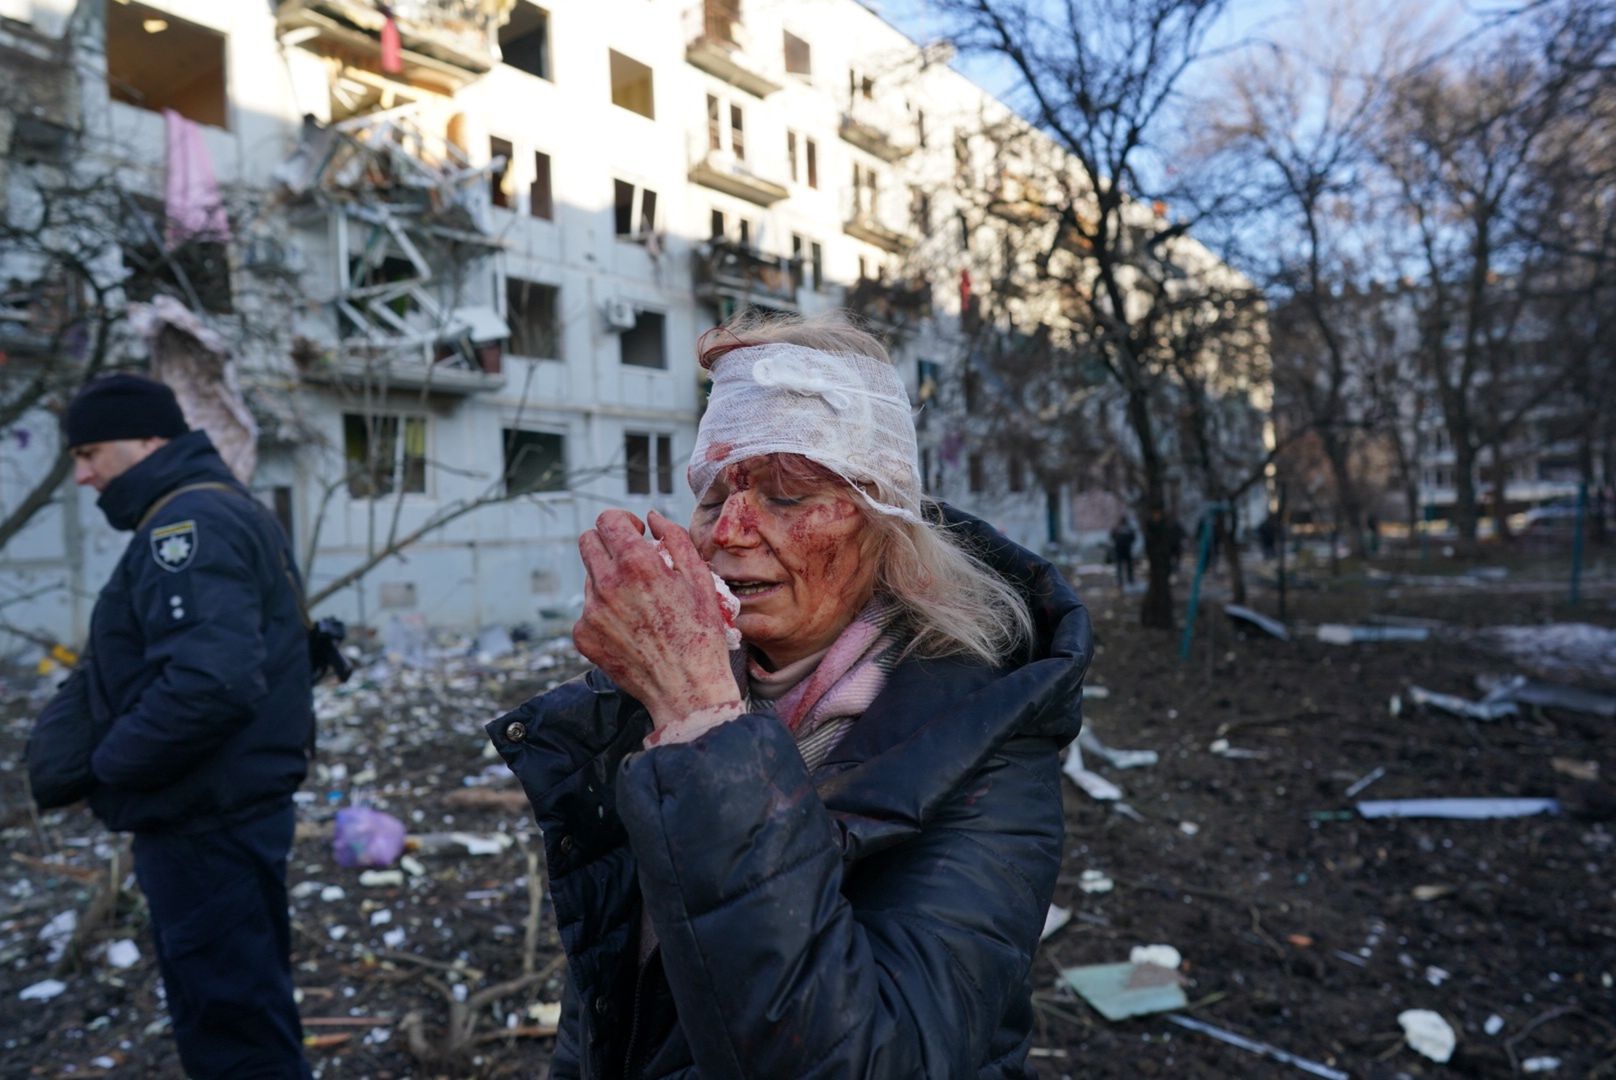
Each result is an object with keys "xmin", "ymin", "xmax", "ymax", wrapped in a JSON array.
[{"xmin": 107, "ymin": 3, "xmax": 229, "ymax": 128}]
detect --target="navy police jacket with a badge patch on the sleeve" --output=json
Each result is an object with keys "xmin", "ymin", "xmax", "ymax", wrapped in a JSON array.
[{"xmin": 66, "ymin": 432, "xmax": 314, "ymax": 833}]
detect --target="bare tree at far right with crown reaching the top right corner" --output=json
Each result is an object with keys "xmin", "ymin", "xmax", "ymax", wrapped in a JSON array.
[{"xmin": 1377, "ymin": 3, "xmax": 1616, "ymax": 540}]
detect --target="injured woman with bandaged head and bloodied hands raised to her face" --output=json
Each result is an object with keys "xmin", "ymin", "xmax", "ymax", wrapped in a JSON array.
[{"xmin": 488, "ymin": 315, "xmax": 1092, "ymax": 1080}]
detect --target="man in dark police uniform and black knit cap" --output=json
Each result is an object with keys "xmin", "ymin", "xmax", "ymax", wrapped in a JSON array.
[{"xmin": 47, "ymin": 373, "xmax": 314, "ymax": 1080}]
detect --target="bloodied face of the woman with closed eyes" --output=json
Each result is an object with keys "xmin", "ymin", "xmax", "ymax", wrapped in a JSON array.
[{"xmin": 690, "ymin": 454, "xmax": 877, "ymax": 668}]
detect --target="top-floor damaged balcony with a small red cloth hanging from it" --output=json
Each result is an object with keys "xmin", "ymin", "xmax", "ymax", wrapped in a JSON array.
[{"xmin": 275, "ymin": 0, "xmax": 509, "ymax": 89}]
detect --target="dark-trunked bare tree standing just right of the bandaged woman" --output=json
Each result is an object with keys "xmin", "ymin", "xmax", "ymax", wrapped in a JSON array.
[{"xmin": 934, "ymin": 0, "xmax": 1223, "ymax": 627}]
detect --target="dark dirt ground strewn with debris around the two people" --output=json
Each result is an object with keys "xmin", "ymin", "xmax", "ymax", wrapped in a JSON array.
[{"xmin": 0, "ymin": 552, "xmax": 1616, "ymax": 1080}]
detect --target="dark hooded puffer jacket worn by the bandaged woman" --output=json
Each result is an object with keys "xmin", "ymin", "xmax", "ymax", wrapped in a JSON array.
[{"xmin": 488, "ymin": 509, "xmax": 1092, "ymax": 1080}]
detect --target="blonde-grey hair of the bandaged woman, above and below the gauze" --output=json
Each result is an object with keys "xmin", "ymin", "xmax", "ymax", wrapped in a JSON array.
[{"xmin": 696, "ymin": 310, "xmax": 1033, "ymax": 664}]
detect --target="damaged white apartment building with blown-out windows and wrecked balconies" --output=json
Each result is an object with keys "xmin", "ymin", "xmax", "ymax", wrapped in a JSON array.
[{"xmin": 0, "ymin": 0, "xmax": 1266, "ymax": 652}]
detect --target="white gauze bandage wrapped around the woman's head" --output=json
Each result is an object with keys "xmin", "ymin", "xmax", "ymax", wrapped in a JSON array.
[{"xmin": 688, "ymin": 343, "xmax": 921, "ymax": 524}]
